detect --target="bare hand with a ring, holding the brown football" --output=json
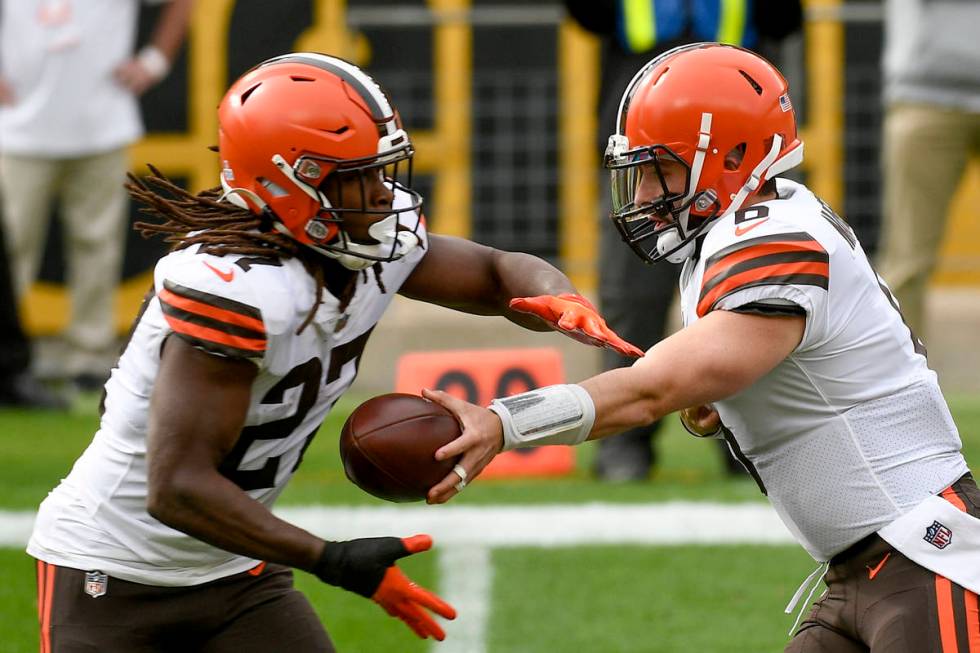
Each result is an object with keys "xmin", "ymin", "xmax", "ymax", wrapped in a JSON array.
[{"xmin": 422, "ymin": 389, "xmax": 504, "ymax": 503}]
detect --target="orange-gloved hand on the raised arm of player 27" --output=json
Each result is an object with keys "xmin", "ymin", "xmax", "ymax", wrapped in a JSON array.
[{"xmin": 510, "ymin": 293, "xmax": 643, "ymax": 358}]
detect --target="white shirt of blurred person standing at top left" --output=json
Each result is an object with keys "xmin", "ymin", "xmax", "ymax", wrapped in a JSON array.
[{"xmin": 0, "ymin": 0, "xmax": 143, "ymax": 158}]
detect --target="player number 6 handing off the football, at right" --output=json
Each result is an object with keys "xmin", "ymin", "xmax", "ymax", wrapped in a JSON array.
[{"xmin": 425, "ymin": 43, "xmax": 980, "ymax": 653}]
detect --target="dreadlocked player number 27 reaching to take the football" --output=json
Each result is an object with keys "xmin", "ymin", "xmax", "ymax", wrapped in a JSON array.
[{"xmin": 28, "ymin": 53, "xmax": 642, "ymax": 653}]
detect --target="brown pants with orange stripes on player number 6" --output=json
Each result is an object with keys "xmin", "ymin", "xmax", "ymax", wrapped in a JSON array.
[{"xmin": 785, "ymin": 474, "xmax": 980, "ymax": 653}]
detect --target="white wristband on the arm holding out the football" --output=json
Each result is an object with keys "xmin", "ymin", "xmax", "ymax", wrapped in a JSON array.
[{"xmin": 489, "ymin": 384, "xmax": 595, "ymax": 451}]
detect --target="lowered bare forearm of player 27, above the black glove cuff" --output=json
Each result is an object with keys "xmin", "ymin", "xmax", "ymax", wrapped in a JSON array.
[{"xmin": 147, "ymin": 471, "xmax": 323, "ymax": 570}]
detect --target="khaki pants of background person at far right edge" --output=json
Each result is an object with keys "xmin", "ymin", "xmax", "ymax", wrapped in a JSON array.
[{"xmin": 878, "ymin": 104, "xmax": 980, "ymax": 338}]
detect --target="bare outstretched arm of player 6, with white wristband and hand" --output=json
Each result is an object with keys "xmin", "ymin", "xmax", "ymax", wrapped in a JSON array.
[{"xmin": 423, "ymin": 311, "xmax": 805, "ymax": 503}]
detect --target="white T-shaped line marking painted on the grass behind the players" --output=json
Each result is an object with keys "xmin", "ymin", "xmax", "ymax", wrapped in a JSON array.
[{"xmin": 0, "ymin": 501, "xmax": 794, "ymax": 653}]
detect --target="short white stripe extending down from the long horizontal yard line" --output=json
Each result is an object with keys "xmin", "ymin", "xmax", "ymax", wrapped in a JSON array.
[{"xmin": 438, "ymin": 545, "xmax": 493, "ymax": 653}]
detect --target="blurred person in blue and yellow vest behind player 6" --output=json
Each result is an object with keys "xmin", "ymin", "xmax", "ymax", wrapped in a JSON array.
[{"xmin": 564, "ymin": 0, "xmax": 802, "ymax": 482}]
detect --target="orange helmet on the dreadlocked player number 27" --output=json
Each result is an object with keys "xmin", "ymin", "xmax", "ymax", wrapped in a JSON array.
[{"xmin": 218, "ymin": 52, "xmax": 422, "ymax": 270}]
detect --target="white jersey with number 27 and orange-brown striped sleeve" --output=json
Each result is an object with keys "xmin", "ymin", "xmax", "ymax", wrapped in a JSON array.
[{"xmin": 27, "ymin": 195, "xmax": 428, "ymax": 586}]
